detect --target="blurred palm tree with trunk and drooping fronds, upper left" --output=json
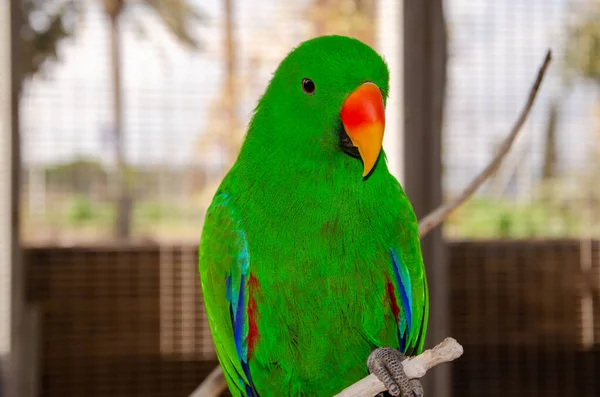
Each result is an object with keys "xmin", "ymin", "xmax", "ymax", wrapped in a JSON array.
[{"xmin": 21, "ymin": 0, "xmax": 204, "ymax": 238}]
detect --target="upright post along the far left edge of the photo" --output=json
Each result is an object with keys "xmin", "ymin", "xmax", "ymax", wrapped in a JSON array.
[{"xmin": 0, "ymin": 0, "xmax": 26, "ymax": 397}]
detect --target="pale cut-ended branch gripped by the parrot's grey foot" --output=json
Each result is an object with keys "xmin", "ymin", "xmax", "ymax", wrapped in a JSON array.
[{"xmin": 334, "ymin": 338, "xmax": 463, "ymax": 397}]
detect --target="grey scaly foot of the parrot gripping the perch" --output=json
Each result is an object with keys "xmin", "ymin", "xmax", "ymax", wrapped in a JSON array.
[{"xmin": 367, "ymin": 347, "xmax": 423, "ymax": 397}]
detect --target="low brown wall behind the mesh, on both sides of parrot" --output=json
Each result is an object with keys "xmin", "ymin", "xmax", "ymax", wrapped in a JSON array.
[{"xmin": 25, "ymin": 240, "xmax": 600, "ymax": 397}]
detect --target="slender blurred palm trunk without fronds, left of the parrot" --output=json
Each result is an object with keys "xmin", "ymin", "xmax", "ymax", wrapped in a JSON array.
[{"xmin": 104, "ymin": 0, "xmax": 132, "ymax": 239}]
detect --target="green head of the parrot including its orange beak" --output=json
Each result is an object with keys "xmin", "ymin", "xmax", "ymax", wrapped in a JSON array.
[{"xmin": 242, "ymin": 36, "xmax": 389, "ymax": 180}]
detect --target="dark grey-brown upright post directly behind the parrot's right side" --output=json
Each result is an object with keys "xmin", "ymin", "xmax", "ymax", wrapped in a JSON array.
[{"xmin": 402, "ymin": 0, "xmax": 451, "ymax": 397}]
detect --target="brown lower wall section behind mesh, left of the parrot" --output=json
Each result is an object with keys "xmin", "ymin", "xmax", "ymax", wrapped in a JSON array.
[{"xmin": 26, "ymin": 246, "xmax": 216, "ymax": 396}]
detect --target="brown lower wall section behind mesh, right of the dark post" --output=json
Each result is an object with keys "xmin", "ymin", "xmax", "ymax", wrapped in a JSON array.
[{"xmin": 450, "ymin": 240, "xmax": 600, "ymax": 396}]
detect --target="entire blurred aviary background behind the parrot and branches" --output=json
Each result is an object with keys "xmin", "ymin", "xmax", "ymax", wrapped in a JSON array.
[{"xmin": 0, "ymin": 0, "xmax": 600, "ymax": 397}]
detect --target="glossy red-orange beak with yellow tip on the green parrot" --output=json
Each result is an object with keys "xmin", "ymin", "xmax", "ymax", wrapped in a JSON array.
[{"xmin": 340, "ymin": 83, "xmax": 385, "ymax": 177}]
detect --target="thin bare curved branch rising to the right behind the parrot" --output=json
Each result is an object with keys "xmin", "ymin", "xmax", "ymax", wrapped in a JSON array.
[{"xmin": 419, "ymin": 50, "xmax": 552, "ymax": 237}]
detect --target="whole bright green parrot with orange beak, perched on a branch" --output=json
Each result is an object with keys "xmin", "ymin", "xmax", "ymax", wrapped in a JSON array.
[{"xmin": 199, "ymin": 36, "xmax": 429, "ymax": 397}]
